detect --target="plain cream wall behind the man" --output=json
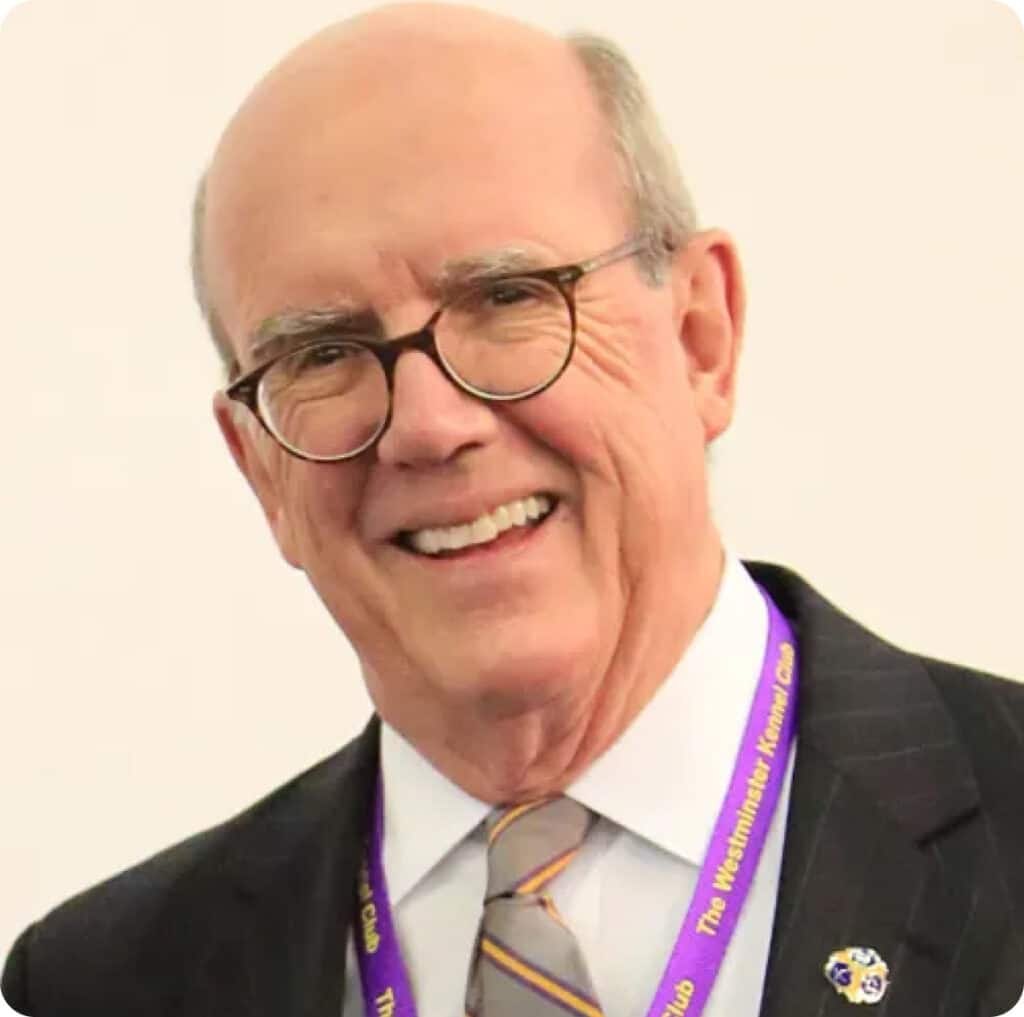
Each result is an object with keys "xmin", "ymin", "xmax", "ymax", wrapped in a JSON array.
[{"xmin": 0, "ymin": 0, "xmax": 1024, "ymax": 955}]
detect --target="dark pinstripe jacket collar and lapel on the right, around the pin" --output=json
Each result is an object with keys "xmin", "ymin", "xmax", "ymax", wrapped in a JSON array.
[{"xmin": 751, "ymin": 565, "xmax": 1006, "ymax": 1017}]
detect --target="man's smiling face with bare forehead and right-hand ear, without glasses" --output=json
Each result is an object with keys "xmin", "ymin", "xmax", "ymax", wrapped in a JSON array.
[{"xmin": 207, "ymin": 15, "xmax": 739, "ymax": 724}]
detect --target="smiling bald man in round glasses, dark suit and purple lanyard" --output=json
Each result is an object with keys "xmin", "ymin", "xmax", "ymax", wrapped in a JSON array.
[{"xmin": 3, "ymin": 6, "xmax": 1024, "ymax": 1017}]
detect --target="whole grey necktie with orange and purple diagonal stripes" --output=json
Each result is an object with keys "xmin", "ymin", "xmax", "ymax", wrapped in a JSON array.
[{"xmin": 466, "ymin": 798, "xmax": 602, "ymax": 1017}]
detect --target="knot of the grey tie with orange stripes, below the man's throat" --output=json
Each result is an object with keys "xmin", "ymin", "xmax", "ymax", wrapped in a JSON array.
[{"xmin": 486, "ymin": 797, "xmax": 596, "ymax": 900}]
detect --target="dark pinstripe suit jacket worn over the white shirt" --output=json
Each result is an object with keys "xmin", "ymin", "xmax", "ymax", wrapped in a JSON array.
[{"xmin": 3, "ymin": 565, "xmax": 1024, "ymax": 1017}]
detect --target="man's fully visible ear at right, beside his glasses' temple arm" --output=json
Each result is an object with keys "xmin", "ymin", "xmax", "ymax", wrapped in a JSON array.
[{"xmin": 673, "ymin": 229, "xmax": 746, "ymax": 444}]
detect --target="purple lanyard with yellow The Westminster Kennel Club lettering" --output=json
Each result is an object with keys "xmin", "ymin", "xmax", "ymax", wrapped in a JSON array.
[{"xmin": 355, "ymin": 590, "xmax": 797, "ymax": 1017}]
